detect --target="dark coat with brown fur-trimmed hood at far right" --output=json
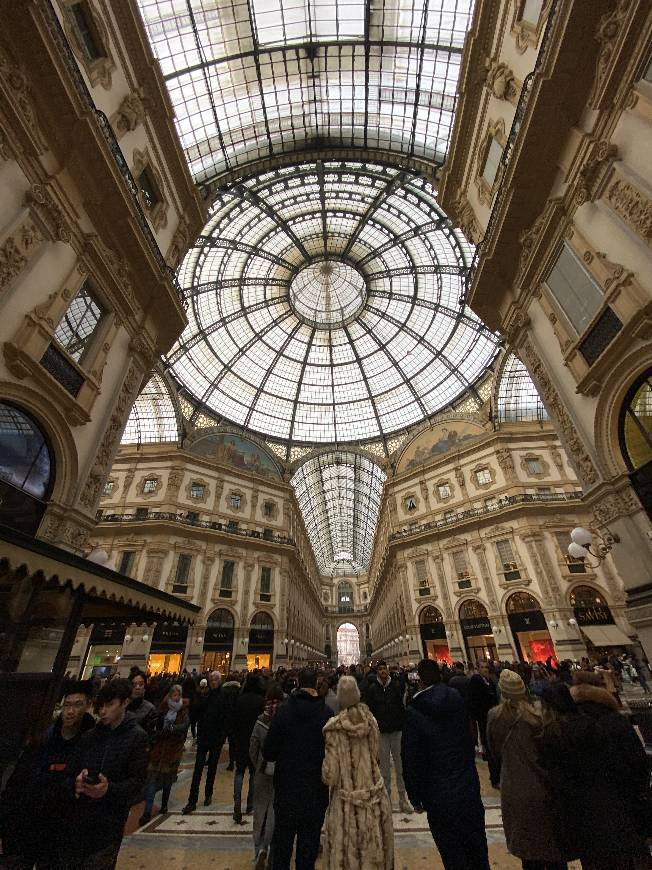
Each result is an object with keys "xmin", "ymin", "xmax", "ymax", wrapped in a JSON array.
[{"xmin": 541, "ymin": 685, "xmax": 649, "ymax": 866}]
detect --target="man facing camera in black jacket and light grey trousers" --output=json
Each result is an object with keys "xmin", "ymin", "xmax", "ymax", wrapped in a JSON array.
[{"xmin": 363, "ymin": 662, "xmax": 412, "ymax": 813}]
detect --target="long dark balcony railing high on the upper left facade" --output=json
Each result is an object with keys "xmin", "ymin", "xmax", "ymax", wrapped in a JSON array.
[{"xmin": 42, "ymin": 0, "xmax": 185, "ymax": 302}]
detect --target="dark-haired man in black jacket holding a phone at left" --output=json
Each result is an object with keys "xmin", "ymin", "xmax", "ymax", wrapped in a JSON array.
[{"xmin": 71, "ymin": 679, "xmax": 147, "ymax": 870}]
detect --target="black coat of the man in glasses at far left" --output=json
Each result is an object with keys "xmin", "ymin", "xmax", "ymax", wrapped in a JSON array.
[{"xmin": 0, "ymin": 713, "xmax": 95, "ymax": 862}]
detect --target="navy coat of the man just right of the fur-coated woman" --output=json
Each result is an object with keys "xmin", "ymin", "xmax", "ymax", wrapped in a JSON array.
[{"xmin": 401, "ymin": 683, "xmax": 480, "ymax": 813}]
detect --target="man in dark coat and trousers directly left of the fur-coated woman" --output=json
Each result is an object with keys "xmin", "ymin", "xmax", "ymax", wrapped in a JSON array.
[{"xmin": 263, "ymin": 668, "xmax": 332, "ymax": 870}]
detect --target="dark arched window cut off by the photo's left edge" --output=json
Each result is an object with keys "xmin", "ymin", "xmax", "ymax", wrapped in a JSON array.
[{"xmin": 0, "ymin": 402, "xmax": 54, "ymax": 535}]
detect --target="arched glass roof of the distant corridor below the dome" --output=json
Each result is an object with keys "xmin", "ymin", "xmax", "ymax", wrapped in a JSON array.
[{"xmin": 292, "ymin": 451, "xmax": 387, "ymax": 574}]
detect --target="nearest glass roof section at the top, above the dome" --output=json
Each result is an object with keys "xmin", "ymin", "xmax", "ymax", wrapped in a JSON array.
[{"xmin": 138, "ymin": 0, "xmax": 473, "ymax": 184}]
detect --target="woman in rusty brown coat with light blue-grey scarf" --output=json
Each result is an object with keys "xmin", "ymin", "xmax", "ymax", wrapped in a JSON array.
[{"xmin": 138, "ymin": 685, "xmax": 190, "ymax": 825}]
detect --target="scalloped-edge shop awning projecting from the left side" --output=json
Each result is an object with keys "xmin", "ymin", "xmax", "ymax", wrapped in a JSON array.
[{"xmin": 0, "ymin": 527, "xmax": 201, "ymax": 625}]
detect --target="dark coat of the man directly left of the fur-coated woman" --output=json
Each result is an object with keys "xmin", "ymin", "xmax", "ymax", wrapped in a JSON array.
[{"xmin": 263, "ymin": 689, "xmax": 332, "ymax": 818}]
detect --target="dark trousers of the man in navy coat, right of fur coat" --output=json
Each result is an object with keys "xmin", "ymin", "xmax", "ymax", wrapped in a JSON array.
[{"xmin": 428, "ymin": 797, "xmax": 489, "ymax": 870}]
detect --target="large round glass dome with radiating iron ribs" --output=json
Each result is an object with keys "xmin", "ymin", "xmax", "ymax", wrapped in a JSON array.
[{"xmin": 167, "ymin": 161, "xmax": 497, "ymax": 443}]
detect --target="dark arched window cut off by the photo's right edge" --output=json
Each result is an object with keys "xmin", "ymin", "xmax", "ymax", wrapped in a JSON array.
[{"xmin": 618, "ymin": 369, "xmax": 652, "ymax": 518}]
